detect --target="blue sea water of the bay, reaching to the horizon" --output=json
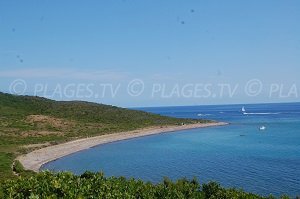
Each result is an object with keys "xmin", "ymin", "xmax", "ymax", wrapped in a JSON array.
[{"xmin": 43, "ymin": 103, "xmax": 300, "ymax": 196}]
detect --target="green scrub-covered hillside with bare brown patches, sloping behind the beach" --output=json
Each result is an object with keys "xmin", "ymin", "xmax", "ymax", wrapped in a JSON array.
[{"xmin": 0, "ymin": 93, "xmax": 208, "ymax": 179}]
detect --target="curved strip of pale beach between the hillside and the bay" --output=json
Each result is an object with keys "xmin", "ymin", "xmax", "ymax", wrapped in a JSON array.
[{"xmin": 16, "ymin": 122, "xmax": 228, "ymax": 172}]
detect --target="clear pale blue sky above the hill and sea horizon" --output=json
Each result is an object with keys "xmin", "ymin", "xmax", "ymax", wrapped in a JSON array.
[{"xmin": 0, "ymin": 0, "xmax": 300, "ymax": 107}]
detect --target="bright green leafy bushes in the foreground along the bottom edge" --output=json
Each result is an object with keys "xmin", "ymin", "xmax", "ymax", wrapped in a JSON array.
[{"xmin": 2, "ymin": 172, "xmax": 282, "ymax": 199}]
